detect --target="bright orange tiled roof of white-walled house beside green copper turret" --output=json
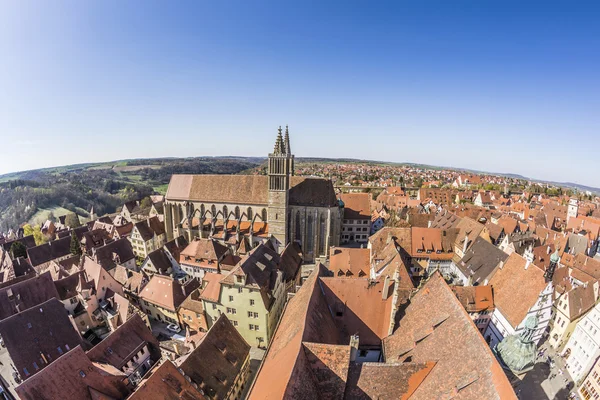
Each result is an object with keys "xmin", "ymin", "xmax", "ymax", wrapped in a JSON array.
[{"xmin": 489, "ymin": 253, "xmax": 547, "ymax": 329}]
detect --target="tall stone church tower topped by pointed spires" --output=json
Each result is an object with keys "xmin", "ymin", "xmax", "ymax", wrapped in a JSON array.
[{"xmin": 267, "ymin": 126, "xmax": 294, "ymax": 250}]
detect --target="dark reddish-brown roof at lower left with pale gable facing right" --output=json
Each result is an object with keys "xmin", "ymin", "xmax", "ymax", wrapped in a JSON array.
[{"xmin": 87, "ymin": 313, "xmax": 160, "ymax": 370}]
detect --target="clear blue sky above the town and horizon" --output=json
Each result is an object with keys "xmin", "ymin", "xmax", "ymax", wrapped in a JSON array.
[{"xmin": 0, "ymin": 0, "xmax": 600, "ymax": 187}]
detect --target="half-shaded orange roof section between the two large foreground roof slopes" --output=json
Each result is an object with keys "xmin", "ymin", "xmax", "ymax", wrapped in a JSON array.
[{"xmin": 321, "ymin": 277, "xmax": 394, "ymax": 346}]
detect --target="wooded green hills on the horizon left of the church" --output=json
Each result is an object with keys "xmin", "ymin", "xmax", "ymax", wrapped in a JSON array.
[{"xmin": 0, "ymin": 157, "xmax": 260, "ymax": 232}]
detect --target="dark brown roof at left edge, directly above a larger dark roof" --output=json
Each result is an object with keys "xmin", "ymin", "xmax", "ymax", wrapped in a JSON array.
[{"xmin": 0, "ymin": 272, "xmax": 59, "ymax": 320}]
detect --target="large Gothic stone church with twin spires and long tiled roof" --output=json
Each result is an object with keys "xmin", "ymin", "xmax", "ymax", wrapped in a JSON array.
[{"xmin": 165, "ymin": 126, "xmax": 343, "ymax": 263}]
